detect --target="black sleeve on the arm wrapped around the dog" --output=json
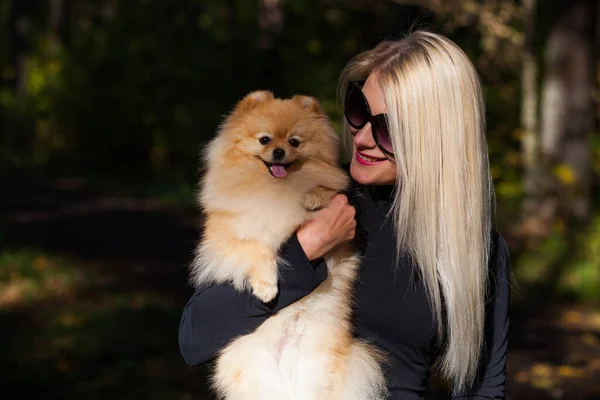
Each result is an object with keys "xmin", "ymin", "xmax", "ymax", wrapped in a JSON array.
[{"xmin": 179, "ymin": 234, "xmax": 327, "ymax": 365}]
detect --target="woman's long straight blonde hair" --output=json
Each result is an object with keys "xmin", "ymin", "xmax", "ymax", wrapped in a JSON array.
[{"xmin": 340, "ymin": 31, "xmax": 494, "ymax": 390}]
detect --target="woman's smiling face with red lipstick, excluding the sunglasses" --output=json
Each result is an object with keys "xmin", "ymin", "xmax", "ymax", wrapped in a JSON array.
[{"xmin": 350, "ymin": 74, "xmax": 396, "ymax": 185}]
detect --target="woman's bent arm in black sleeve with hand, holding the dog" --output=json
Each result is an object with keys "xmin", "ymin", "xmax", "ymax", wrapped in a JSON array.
[{"xmin": 179, "ymin": 194, "xmax": 356, "ymax": 365}]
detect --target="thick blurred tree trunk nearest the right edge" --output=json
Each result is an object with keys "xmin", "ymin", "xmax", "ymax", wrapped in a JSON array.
[{"xmin": 536, "ymin": 0, "xmax": 596, "ymax": 229}]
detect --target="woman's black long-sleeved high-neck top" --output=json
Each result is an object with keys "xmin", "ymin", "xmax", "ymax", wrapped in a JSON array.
[{"xmin": 179, "ymin": 183, "xmax": 510, "ymax": 400}]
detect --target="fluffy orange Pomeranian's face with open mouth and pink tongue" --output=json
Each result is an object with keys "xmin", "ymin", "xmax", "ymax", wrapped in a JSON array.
[{"xmin": 216, "ymin": 91, "xmax": 338, "ymax": 179}]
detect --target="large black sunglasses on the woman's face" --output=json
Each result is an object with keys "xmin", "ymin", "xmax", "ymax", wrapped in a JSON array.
[{"xmin": 344, "ymin": 81, "xmax": 394, "ymax": 158}]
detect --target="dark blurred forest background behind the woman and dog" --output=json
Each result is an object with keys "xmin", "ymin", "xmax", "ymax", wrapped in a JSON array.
[{"xmin": 0, "ymin": 0, "xmax": 600, "ymax": 399}]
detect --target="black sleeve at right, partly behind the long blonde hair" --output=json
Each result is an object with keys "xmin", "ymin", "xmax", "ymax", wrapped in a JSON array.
[{"xmin": 453, "ymin": 234, "xmax": 510, "ymax": 399}]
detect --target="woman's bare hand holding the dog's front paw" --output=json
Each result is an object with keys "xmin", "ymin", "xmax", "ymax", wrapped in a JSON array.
[{"xmin": 297, "ymin": 194, "xmax": 356, "ymax": 261}]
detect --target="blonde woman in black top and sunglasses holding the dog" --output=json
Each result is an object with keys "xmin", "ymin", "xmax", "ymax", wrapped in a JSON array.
[{"xmin": 179, "ymin": 31, "xmax": 510, "ymax": 399}]
